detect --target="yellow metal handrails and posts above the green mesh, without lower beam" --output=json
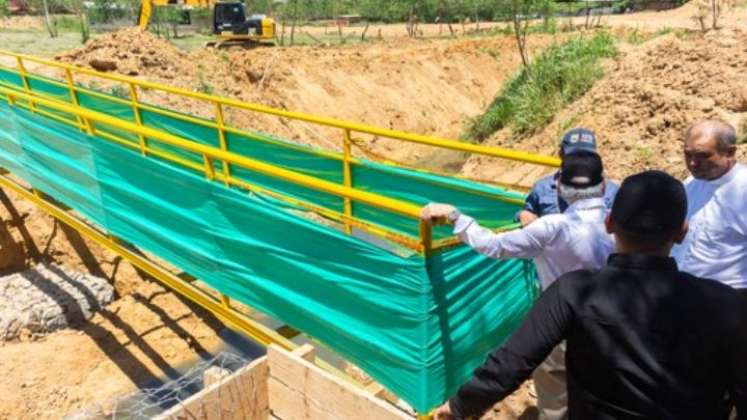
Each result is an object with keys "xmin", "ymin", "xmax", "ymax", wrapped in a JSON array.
[{"xmin": 0, "ymin": 51, "xmax": 559, "ymax": 253}]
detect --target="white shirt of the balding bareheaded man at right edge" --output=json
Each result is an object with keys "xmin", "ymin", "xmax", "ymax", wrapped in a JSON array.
[{"xmin": 672, "ymin": 163, "xmax": 747, "ymax": 289}]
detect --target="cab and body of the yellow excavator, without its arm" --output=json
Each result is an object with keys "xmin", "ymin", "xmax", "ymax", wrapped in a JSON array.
[{"xmin": 213, "ymin": 2, "xmax": 275, "ymax": 41}]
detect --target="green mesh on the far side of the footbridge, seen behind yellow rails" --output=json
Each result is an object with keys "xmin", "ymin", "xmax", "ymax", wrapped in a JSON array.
[{"xmin": 0, "ymin": 69, "xmax": 523, "ymax": 239}]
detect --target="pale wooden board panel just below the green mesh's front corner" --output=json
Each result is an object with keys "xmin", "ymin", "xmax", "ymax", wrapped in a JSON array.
[{"xmin": 267, "ymin": 345, "xmax": 412, "ymax": 420}]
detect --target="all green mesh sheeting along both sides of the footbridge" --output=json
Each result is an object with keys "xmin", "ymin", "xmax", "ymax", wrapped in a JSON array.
[{"xmin": 0, "ymin": 72, "xmax": 536, "ymax": 412}]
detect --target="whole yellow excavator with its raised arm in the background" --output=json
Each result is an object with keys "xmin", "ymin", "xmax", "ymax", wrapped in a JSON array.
[{"xmin": 138, "ymin": 0, "xmax": 275, "ymax": 46}]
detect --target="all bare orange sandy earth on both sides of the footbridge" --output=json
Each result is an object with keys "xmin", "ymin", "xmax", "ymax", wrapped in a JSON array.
[{"xmin": 0, "ymin": 2, "xmax": 747, "ymax": 419}]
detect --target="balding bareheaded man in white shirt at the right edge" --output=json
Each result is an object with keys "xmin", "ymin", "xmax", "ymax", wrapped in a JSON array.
[{"xmin": 672, "ymin": 121, "xmax": 747, "ymax": 298}]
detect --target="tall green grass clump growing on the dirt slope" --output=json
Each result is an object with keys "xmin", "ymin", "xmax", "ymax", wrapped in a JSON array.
[{"xmin": 463, "ymin": 32, "xmax": 617, "ymax": 141}]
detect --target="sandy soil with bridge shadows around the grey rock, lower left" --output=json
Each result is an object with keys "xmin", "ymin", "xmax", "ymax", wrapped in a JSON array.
[{"xmin": 0, "ymin": 185, "xmax": 226, "ymax": 419}]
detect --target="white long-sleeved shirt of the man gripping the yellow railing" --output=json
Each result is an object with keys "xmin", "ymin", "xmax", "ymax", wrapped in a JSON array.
[{"xmin": 454, "ymin": 198, "xmax": 614, "ymax": 290}]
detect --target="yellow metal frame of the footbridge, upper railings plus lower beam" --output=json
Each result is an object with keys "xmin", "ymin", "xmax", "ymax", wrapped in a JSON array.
[{"xmin": 0, "ymin": 51, "xmax": 560, "ymax": 418}]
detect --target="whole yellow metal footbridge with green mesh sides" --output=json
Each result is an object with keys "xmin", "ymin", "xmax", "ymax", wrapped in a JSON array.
[{"xmin": 0, "ymin": 52, "xmax": 559, "ymax": 413}]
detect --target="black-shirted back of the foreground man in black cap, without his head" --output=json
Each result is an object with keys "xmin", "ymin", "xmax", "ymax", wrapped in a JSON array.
[{"xmin": 559, "ymin": 254, "xmax": 747, "ymax": 419}]
